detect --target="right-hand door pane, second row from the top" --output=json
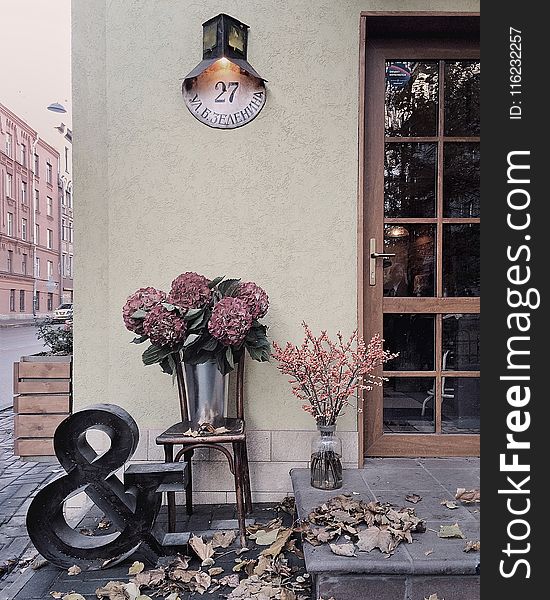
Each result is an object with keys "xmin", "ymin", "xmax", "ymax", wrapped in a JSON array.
[{"xmin": 443, "ymin": 142, "xmax": 479, "ymax": 218}]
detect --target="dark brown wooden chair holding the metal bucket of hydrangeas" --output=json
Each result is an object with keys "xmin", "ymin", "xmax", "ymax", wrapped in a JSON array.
[{"xmin": 156, "ymin": 354, "xmax": 252, "ymax": 546}]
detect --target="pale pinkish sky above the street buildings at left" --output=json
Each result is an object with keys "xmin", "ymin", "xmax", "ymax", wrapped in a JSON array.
[{"xmin": 0, "ymin": 0, "xmax": 72, "ymax": 151}]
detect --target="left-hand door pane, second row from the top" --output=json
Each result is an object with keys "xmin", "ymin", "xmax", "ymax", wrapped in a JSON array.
[{"xmin": 384, "ymin": 142, "xmax": 437, "ymax": 217}]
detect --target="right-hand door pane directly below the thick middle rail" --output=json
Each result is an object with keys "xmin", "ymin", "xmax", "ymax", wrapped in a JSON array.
[{"xmin": 442, "ymin": 314, "xmax": 479, "ymax": 371}]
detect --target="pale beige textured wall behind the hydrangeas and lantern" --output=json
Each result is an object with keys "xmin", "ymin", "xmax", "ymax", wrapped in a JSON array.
[{"xmin": 73, "ymin": 0, "xmax": 479, "ymax": 500}]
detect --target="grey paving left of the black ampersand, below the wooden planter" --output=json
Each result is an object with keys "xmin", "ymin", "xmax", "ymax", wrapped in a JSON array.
[{"xmin": 0, "ymin": 408, "xmax": 59, "ymax": 597}]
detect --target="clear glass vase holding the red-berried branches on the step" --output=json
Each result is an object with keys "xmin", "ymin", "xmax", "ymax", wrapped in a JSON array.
[{"xmin": 310, "ymin": 425, "xmax": 342, "ymax": 490}]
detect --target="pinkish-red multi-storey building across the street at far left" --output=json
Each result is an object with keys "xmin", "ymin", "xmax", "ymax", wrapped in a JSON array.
[{"xmin": 0, "ymin": 104, "xmax": 63, "ymax": 319}]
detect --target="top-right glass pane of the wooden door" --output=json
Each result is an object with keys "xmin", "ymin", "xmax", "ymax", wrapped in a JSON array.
[{"xmin": 445, "ymin": 60, "xmax": 480, "ymax": 136}]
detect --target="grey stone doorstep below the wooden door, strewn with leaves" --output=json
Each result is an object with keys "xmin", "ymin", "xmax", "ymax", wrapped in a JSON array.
[{"xmin": 291, "ymin": 458, "xmax": 480, "ymax": 600}]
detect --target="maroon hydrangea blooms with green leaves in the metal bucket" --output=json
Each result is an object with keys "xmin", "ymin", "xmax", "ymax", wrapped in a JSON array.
[{"xmin": 122, "ymin": 273, "xmax": 271, "ymax": 375}]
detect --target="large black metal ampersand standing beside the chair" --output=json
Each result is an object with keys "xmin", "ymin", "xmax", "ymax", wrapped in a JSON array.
[{"xmin": 27, "ymin": 404, "xmax": 186, "ymax": 570}]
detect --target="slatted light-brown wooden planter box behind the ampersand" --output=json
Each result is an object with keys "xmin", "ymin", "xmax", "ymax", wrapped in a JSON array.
[{"xmin": 13, "ymin": 356, "xmax": 72, "ymax": 458}]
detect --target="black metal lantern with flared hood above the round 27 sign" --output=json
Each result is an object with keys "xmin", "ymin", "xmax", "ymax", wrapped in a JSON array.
[{"xmin": 185, "ymin": 13, "xmax": 266, "ymax": 81}]
